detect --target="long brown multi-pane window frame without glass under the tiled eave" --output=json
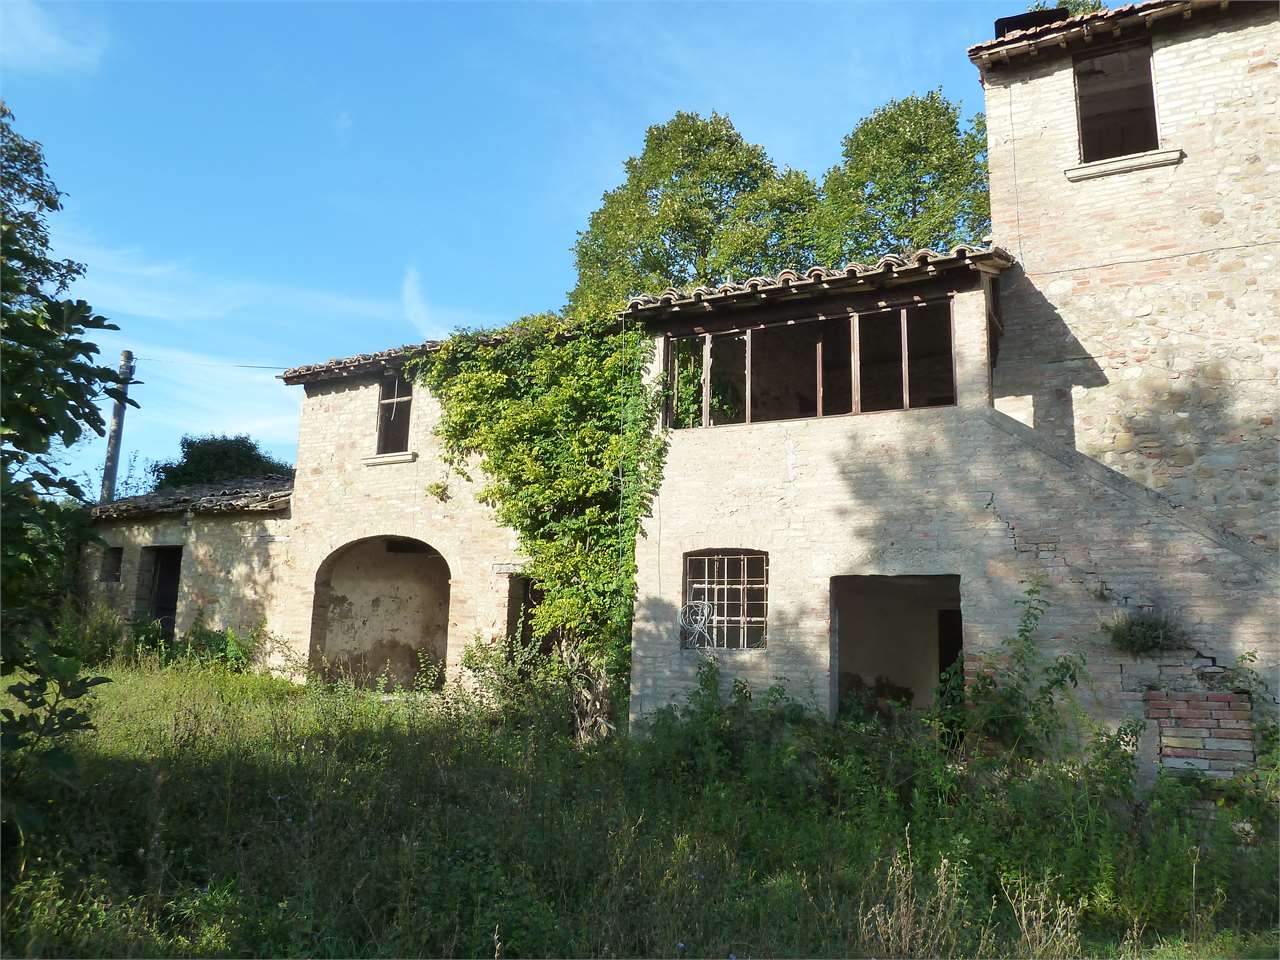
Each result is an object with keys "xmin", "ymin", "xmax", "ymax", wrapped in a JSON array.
[{"xmin": 662, "ymin": 293, "xmax": 960, "ymax": 430}]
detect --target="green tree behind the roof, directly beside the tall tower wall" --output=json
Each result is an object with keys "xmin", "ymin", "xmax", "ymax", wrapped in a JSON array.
[{"xmin": 817, "ymin": 91, "xmax": 991, "ymax": 265}]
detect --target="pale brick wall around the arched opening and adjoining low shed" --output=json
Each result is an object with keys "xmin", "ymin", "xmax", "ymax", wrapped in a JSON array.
[{"xmin": 84, "ymin": 378, "xmax": 521, "ymax": 676}]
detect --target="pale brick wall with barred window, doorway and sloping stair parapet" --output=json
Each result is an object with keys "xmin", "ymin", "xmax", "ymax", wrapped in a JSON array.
[{"xmin": 631, "ymin": 293, "xmax": 1280, "ymax": 721}]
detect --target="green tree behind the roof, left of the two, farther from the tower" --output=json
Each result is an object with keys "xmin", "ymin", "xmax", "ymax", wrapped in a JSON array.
[{"xmin": 570, "ymin": 113, "xmax": 818, "ymax": 317}]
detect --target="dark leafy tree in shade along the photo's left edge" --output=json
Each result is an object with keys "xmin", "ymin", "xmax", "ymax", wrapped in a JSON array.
[{"xmin": 0, "ymin": 104, "xmax": 122, "ymax": 844}]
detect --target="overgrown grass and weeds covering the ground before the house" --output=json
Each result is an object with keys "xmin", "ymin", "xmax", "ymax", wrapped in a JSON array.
[{"xmin": 4, "ymin": 658, "xmax": 1277, "ymax": 957}]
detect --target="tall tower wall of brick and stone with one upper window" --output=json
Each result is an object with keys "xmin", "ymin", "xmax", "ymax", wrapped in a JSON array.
[{"xmin": 983, "ymin": 4, "xmax": 1280, "ymax": 548}]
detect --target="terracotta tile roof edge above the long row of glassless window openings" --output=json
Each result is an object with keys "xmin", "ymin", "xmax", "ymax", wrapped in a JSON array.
[{"xmin": 626, "ymin": 243, "xmax": 1014, "ymax": 314}]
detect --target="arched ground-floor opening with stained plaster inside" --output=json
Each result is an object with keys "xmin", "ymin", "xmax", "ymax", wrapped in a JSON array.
[{"xmin": 311, "ymin": 536, "xmax": 449, "ymax": 686}]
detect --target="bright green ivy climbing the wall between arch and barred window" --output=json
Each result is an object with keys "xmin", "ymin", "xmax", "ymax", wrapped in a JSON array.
[{"xmin": 408, "ymin": 314, "xmax": 664, "ymax": 699}]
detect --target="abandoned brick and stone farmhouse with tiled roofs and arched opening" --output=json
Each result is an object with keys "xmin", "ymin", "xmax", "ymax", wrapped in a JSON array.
[{"xmin": 85, "ymin": 0, "xmax": 1280, "ymax": 776}]
